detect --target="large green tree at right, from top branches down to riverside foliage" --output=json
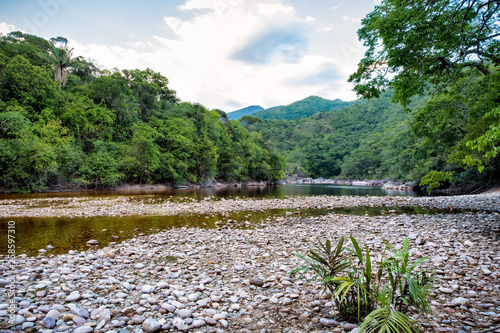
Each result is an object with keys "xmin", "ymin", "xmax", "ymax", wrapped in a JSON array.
[{"xmin": 349, "ymin": 0, "xmax": 500, "ymax": 182}]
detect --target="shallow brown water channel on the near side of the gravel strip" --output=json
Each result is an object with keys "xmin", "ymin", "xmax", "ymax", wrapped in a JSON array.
[{"xmin": 0, "ymin": 206, "xmax": 468, "ymax": 255}]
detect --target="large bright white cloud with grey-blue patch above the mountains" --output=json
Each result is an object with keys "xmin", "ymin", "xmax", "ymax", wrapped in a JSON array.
[{"xmin": 0, "ymin": 0, "xmax": 370, "ymax": 111}]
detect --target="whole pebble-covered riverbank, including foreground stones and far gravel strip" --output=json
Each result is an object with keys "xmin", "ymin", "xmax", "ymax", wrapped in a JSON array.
[{"xmin": 0, "ymin": 193, "xmax": 500, "ymax": 333}]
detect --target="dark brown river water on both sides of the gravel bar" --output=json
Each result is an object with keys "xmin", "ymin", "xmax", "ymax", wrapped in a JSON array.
[{"xmin": 0, "ymin": 184, "xmax": 432, "ymax": 255}]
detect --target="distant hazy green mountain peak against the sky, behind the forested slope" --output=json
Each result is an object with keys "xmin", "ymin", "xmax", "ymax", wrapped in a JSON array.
[{"xmin": 252, "ymin": 96, "xmax": 353, "ymax": 120}]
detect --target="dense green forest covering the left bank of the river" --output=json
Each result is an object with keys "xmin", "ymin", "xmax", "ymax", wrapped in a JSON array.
[{"xmin": 0, "ymin": 32, "xmax": 284, "ymax": 192}]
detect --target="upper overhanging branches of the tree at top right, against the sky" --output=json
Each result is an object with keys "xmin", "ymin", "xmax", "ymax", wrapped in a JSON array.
[{"xmin": 349, "ymin": 0, "xmax": 500, "ymax": 105}]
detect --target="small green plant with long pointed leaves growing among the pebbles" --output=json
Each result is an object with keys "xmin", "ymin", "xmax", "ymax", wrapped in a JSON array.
[{"xmin": 291, "ymin": 236, "xmax": 434, "ymax": 333}]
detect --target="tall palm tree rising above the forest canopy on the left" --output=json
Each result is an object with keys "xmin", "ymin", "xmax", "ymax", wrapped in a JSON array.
[{"xmin": 39, "ymin": 37, "xmax": 77, "ymax": 88}]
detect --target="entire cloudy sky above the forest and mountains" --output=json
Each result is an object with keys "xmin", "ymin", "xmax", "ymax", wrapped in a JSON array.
[{"xmin": 0, "ymin": 0, "xmax": 378, "ymax": 112}]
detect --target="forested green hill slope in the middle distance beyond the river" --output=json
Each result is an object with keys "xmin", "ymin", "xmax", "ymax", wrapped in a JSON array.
[{"xmin": 247, "ymin": 93, "xmax": 414, "ymax": 178}]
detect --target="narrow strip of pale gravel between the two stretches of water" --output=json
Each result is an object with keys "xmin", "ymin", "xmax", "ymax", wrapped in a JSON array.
[{"xmin": 0, "ymin": 193, "xmax": 500, "ymax": 218}]
